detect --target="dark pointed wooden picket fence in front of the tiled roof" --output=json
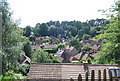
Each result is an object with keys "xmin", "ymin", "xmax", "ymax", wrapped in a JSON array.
[{"xmin": 70, "ymin": 69, "xmax": 120, "ymax": 81}]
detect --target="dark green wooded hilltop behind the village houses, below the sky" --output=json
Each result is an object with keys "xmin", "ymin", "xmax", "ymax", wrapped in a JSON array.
[{"xmin": 33, "ymin": 19, "xmax": 109, "ymax": 40}]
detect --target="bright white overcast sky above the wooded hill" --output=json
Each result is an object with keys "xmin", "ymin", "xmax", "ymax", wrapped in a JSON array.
[{"xmin": 7, "ymin": 0, "xmax": 114, "ymax": 27}]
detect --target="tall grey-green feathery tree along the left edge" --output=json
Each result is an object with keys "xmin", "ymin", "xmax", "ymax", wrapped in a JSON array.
[{"xmin": 1, "ymin": 1, "xmax": 29, "ymax": 74}]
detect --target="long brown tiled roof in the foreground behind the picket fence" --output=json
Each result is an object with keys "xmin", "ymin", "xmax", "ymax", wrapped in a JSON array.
[{"xmin": 29, "ymin": 63, "xmax": 120, "ymax": 79}]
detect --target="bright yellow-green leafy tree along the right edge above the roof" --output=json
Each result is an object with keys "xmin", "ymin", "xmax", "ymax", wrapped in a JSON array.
[{"xmin": 95, "ymin": 0, "xmax": 120, "ymax": 64}]
